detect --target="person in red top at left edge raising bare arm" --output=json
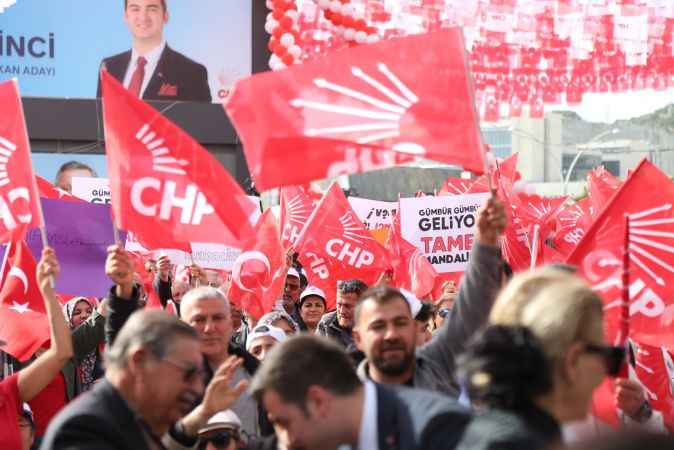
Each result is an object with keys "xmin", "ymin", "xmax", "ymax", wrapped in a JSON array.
[{"xmin": 0, "ymin": 248, "xmax": 73, "ymax": 450}]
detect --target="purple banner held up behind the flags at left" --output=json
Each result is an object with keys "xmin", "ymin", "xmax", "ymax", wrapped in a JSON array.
[{"xmin": 15, "ymin": 198, "xmax": 122, "ymax": 297}]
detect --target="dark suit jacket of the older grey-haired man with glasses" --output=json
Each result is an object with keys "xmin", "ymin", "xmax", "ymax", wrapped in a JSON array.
[{"xmin": 40, "ymin": 380, "xmax": 154, "ymax": 450}]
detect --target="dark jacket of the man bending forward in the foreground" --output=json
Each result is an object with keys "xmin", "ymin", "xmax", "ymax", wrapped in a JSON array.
[{"xmin": 376, "ymin": 385, "xmax": 470, "ymax": 450}]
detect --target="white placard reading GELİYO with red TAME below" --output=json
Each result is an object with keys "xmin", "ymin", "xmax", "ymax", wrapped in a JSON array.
[{"xmin": 400, "ymin": 193, "xmax": 489, "ymax": 273}]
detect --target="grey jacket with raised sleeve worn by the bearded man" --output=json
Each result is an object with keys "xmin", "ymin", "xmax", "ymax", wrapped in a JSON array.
[{"xmin": 358, "ymin": 242, "xmax": 502, "ymax": 398}]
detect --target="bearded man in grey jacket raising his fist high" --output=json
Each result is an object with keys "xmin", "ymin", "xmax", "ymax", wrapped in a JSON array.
[{"xmin": 354, "ymin": 197, "xmax": 506, "ymax": 398}]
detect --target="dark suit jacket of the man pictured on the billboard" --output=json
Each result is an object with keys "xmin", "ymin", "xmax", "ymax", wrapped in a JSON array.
[{"xmin": 96, "ymin": 45, "xmax": 211, "ymax": 102}]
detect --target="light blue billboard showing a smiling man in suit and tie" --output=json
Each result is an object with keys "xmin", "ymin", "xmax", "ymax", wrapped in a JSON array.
[{"xmin": 0, "ymin": 0, "xmax": 253, "ymax": 103}]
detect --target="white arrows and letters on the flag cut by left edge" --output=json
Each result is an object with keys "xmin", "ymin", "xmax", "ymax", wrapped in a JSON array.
[{"xmin": 0, "ymin": 136, "xmax": 33, "ymax": 231}]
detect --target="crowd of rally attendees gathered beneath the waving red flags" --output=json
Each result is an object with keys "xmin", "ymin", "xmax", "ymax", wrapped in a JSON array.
[{"xmin": 0, "ymin": 167, "xmax": 674, "ymax": 450}]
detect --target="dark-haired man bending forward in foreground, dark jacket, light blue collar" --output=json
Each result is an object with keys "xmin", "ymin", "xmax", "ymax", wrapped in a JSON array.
[{"xmin": 250, "ymin": 335, "xmax": 469, "ymax": 450}]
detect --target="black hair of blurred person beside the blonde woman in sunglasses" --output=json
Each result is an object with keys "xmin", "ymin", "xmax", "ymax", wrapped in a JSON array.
[{"xmin": 458, "ymin": 325, "xmax": 552, "ymax": 410}]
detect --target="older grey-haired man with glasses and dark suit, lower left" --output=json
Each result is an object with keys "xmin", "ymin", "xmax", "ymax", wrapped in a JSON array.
[{"xmin": 40, "ymin": 311, "xmax": 203, "ymax": 450}]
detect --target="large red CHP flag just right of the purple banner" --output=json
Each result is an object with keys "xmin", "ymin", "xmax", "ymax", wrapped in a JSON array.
[{"xmin": 101, "ymin": 71, "xmax": 254, "ymax": 251}]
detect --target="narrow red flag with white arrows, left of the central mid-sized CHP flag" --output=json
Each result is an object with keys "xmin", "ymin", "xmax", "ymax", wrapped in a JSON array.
[{"xmin": 280, "ymin": 186, "xmax": 320, "ymax": 248}]
